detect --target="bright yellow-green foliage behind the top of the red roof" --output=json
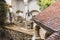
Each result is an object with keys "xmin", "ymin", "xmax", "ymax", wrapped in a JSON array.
[{"xmin": 38, "ymin": 0, "xmax": 55, "ymax": 10}]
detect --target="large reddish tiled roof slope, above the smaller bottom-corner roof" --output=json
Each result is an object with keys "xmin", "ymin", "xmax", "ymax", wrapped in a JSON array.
[{"xmin": 34, "ymin": 0, "xmax": 60, "ymax": 31}]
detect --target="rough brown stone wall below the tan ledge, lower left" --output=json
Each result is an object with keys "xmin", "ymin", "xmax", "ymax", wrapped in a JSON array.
[{"xmin": 0, "ymin": 29, "xmax": 32, "ymax": 40}]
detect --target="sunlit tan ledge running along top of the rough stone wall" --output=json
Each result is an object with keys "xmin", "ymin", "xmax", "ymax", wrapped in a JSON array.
[{"xmin": 6, "ymin": 26, "xmax": 34, "ymax": 35}]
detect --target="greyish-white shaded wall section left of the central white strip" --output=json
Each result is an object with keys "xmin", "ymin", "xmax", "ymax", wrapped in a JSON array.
[{"xmin": 12, "ymin": 0, "xmax": 24, "ymax": 13}]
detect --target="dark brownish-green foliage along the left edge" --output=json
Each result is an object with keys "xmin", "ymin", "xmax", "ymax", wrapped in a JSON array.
[{"xmin": 0, "ymin": 0, "xmax": 7, "ymax": 25}]
